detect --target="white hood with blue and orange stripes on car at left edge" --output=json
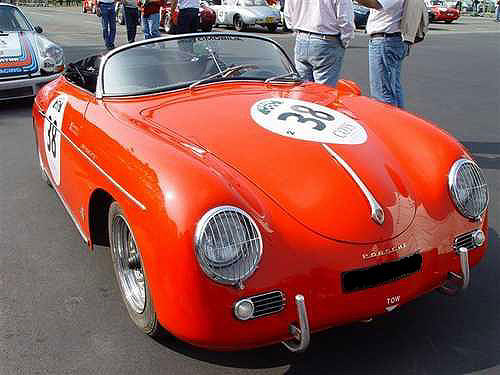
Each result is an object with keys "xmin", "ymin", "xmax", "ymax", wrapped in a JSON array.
[{"xmin": 0, "ymin": 31, "xmax": 39, "ymax": 78}]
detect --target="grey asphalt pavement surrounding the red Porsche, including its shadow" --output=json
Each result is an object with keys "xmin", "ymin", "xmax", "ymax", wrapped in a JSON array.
[{"xmin": 0, "ymin": 8, "xmax": 500, "ymax": 375}]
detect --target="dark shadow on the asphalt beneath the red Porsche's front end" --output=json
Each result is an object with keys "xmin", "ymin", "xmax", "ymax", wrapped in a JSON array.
[{"xmin": 153, "ymin": 228, "xmax": 500, "ymax": 374}]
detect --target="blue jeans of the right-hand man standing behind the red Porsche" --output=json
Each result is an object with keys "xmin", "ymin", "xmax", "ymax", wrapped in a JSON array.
[{"xmin": 368, "ymin": 36, "xmax": 409, "ymax": 108}]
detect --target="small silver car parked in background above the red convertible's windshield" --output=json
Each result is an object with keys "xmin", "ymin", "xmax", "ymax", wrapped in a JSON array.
[{"xmin": 211, "ymin": 0, "xmax": 281, "ymax": 32}]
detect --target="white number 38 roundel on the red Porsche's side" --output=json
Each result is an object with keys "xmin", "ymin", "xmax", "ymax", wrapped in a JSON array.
[{"xmin": 43, "ymin": 95, "xmax": 68, "ymax": 186}]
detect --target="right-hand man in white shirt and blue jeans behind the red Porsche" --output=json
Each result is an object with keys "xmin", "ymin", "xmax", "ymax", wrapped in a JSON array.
[{"xmin": 358, "ymin": 0, "xmax": 409, "ymax": 108}]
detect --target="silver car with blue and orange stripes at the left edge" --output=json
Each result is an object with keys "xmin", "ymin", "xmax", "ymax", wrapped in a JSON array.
[{"xmin": 0, "ymin": 3, "xmax": 64, "ymax": 101}]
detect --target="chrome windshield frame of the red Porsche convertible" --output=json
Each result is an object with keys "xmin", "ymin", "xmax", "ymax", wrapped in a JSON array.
[{"xmin": 95, "ymin": 32, "xmax": 299, "ymax": 99}]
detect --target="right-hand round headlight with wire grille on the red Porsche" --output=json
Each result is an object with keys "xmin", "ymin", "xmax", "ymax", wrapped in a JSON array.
[{"xmin": 448, "ymin": 159, "xmax": 489, "ymax": 219}]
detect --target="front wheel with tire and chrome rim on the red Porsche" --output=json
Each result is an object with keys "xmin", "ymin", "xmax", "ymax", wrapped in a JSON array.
[{"xmin": 108, "ymin": 202, "xmax": 161, "ymax": 336}]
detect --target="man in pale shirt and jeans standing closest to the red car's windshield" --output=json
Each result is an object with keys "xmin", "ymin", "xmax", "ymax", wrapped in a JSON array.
[{"xmin": 284, "ymin": 0, "xmax": 355, "ymax": 86}]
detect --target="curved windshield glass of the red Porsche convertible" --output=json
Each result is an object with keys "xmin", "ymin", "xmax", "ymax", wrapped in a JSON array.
[{"xmin": 102, "ymin": 34, "xmax": 295, "ymax": 96}]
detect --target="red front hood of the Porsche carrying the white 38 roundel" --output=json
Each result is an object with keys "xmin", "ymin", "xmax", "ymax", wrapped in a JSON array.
[{"xmin": 141, "ymin": 84, "xmax": 416, "ymax": 243}]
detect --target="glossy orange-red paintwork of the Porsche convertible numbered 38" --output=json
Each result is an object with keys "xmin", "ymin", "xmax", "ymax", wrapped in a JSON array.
[{"xmin": 33, "ymin": 77, "xmax": 488, "ymax": 350}]
